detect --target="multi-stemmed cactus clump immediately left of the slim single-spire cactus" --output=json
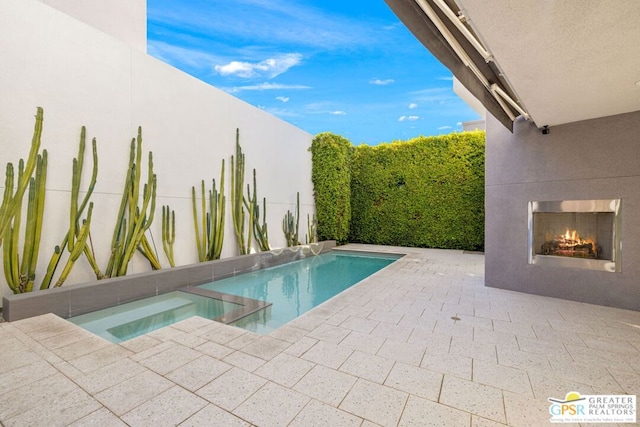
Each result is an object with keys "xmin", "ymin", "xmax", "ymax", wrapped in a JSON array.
[{"xmin": 191, "ymin": 159, "xmax": 226, "ymax": 262}]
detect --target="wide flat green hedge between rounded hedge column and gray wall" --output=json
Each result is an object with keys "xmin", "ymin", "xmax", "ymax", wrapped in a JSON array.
[{"xmin": 350, "ymin": 132, "xmax": 484, "ymax": 250}]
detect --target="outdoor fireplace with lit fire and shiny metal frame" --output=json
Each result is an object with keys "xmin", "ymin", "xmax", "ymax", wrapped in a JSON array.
[{"xmin": 528, "ymin": 199, "xmax": 621, "ymax": 272}]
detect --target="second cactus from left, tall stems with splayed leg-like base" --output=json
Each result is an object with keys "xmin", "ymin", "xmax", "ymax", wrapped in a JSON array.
[{"xmin": 40, "ymin": 126, "xmax": 103, "ymax": 289}]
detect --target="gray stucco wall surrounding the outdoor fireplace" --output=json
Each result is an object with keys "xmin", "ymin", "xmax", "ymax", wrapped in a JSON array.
[{"xmin": 485, "ymin": 112, "xmax": 640, "ymax": 310}]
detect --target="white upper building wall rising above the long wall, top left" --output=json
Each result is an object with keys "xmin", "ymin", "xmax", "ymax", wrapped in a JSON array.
[{"xmin": 40, "ymin": 0, "xmax": 147, "ymax": 52}]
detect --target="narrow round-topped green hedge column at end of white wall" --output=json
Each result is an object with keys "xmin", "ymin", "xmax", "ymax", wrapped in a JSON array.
[{"xmin": 310, "ymin": 132, "xmax": 354, "ymax": 243}]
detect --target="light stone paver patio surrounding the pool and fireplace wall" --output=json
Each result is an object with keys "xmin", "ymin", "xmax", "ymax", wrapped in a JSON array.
[{"xmin": 0, "ymin": 245, "xmax": 640, "ymax": 427}]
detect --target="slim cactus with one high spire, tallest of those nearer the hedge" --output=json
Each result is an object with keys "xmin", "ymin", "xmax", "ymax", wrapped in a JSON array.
[{"xmin": 231, "ymin": 129, "xmax": 254, "ymax": 255}]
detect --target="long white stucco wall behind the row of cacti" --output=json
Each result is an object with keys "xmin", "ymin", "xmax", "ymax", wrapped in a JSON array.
[{"xmin": 0, "ymin": 0, "xmax": 314, "ymax": 300}]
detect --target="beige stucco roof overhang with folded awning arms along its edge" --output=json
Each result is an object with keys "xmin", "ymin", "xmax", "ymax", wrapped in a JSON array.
[{"xmin": 385, "ymin": 0, "xmax": 640, "ymax": 129}]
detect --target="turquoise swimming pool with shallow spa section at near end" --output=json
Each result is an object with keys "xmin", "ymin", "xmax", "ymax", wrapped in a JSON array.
[{"xmin": 68, "ymin": 250, "xmax": 402, "ymax": 343}]
